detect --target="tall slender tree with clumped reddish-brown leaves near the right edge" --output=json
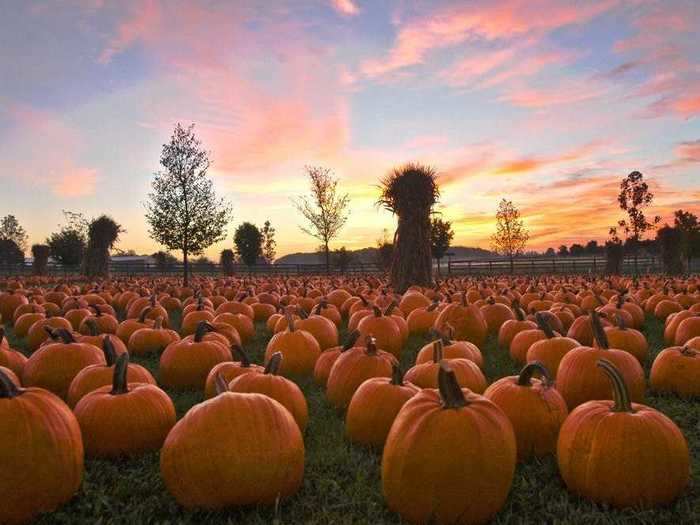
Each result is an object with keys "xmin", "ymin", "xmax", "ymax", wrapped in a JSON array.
[{"xmin": 610, "ymin": 171, "xmax": 661, "ymax": 273}]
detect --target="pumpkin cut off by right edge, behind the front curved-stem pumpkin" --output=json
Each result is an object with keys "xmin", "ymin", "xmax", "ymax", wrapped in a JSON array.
[{"xmin": 649, "ymin": 346, "xmax": 700, "ymax": 397}]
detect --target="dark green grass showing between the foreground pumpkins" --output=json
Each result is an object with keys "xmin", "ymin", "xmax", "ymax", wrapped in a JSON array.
[{"xmin": 8, "ymin": 312, "xmax": 700, "ymax": 524}]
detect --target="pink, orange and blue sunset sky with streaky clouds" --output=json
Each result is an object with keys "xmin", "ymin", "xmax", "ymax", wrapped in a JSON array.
[{"xmin": 0, "ymin": 0, "xmax": 700, "ymax": 257}]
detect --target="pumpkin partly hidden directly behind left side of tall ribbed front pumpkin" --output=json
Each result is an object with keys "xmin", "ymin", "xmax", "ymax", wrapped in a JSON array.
[{"xmin": 345, "ymin": 362, "xmax": 420, "ymax": 450}]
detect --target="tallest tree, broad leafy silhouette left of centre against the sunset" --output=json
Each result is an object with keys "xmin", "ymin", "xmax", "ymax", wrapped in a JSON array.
[{"xmin": 146, "ymin": 123, "xmax": 231, "ymax": 286}]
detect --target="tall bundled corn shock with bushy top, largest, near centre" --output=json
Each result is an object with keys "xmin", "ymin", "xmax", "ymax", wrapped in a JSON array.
[{"xmin": 378, "ymin": 164, "xmax": 440, "ymax": 293}]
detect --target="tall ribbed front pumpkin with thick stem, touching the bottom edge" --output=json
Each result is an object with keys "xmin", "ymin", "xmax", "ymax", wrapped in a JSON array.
[{"xmin": 382, "ymin": 363, "xmax": 516, "ymax": 525}]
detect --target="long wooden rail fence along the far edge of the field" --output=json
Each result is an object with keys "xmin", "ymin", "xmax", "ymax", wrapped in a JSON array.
[{"xmin": 0, "ymin": 256, "xmax": 700, "ymax": 277}]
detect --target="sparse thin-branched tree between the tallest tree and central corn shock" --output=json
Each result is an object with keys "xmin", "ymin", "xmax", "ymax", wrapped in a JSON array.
[{"xmin": 293, "ymin": 166, "xmax": 350, "ymax": 271}]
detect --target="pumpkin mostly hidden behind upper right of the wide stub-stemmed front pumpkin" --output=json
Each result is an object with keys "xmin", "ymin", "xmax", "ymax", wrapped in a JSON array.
[{"xmin": 228, "ymin": 352, "xmax": 309, "ymax": 432}]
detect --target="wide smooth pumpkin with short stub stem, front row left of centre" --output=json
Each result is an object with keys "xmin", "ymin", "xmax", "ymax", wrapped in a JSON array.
[{"xmin": 160, "ymin": 377, "xmax": 304, "ymax": 510}]
